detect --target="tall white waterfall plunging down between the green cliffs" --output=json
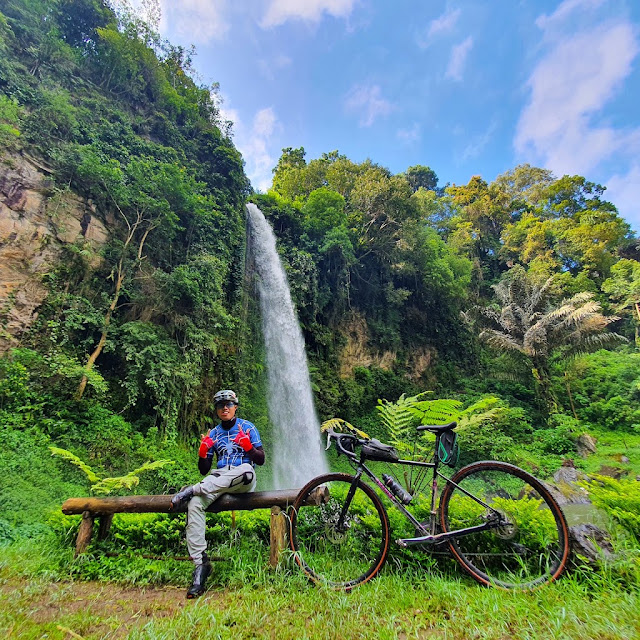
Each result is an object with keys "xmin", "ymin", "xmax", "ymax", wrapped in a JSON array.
[{"xmin": 247, "ymin": 203, "xmax": 327, "ymax": 489}]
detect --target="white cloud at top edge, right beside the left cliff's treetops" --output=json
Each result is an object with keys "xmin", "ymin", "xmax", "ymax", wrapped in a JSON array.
[{"xmin": 160, "ymin": 0, "xmax": 229, "ymax": 44}]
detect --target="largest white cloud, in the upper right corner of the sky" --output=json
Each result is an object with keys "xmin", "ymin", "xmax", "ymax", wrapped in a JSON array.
[{"xmin": 514, "ymin": 6, "xmax": 640, "ymax": 180}]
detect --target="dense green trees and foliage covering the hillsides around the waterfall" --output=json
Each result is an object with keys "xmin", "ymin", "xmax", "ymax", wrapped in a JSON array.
[{"xmin": 0, "ymin": 0, "xmax": 640, "ymax": 568}]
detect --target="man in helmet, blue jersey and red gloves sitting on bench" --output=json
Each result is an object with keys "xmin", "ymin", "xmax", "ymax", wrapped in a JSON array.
[{"xmin": 171, "ymin": 389, "xmax": 264, "ymax": 598}]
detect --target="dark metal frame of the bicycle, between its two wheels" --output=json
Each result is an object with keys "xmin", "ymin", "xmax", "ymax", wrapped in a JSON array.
[{"xmin": 338, "ymin": 433, "xmax": 503, "ymax": 548}]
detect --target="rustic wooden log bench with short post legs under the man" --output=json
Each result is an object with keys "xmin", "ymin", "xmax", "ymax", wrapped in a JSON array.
[{"xmin": 61, "ymin": 487, "xmax": 329, "ymax": 567}]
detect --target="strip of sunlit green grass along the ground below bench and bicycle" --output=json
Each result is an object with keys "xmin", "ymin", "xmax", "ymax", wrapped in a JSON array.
[{"xmin": 0, "ymin": 540, "xmax": 640, "ymax": 640}]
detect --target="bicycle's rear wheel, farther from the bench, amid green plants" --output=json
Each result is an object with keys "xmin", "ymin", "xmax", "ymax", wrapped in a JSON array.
[{"xmin": 440, "ymin": 461, "xmax": 569, "ymax": 589}]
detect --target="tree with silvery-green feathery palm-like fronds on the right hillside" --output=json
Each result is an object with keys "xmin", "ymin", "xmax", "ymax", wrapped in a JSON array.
[{"xmin": 476, "ymin": 266, "xmax": 625, "ymax": 414}]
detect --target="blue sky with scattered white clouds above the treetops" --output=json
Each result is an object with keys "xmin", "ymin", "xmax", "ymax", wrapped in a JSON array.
[{"xmin": 154, "ymin": 0, "xmax": 640, "ymax": 231}]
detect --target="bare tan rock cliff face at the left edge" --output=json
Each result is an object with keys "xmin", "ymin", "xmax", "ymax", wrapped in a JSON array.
[{"xmin": 0, "ymin": 155, "xmax": 107, "ymax": 352}]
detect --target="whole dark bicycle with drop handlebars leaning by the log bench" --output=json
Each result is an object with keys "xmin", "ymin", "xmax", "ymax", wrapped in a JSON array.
[{"xmin": 290, "ymin": 422, "xmax": 569, "ymax": 591}]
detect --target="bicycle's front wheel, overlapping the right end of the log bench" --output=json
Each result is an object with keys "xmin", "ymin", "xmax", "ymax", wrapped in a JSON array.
[{"xmin": 291, "ymin": 473, "xmax": 390, "ymax": 591}]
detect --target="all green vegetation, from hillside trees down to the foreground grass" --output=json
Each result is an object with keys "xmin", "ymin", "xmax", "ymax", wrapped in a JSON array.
[{"xmin": 0, "ymin": 0, "xmax": 640, "ymax": 638}]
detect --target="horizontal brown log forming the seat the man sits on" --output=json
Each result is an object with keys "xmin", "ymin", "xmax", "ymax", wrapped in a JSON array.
[{"xmin": 61, "ymin": 487, "xmax": 329, "ymax": 516}]
